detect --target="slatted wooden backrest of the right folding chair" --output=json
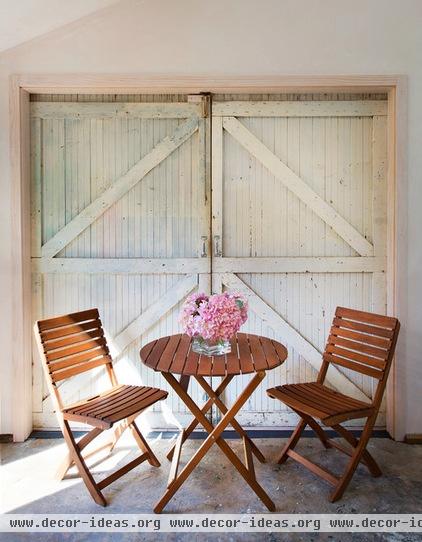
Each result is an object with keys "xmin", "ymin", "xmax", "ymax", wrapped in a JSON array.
[{"xmin": 318, "ymin": 307, "xmax": 400, "ymax": 406}]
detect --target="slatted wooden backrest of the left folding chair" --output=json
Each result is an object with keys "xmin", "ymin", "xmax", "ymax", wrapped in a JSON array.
[{"xmin": 35, "ymin": 309, "xmax": 116, "ymax": 408}]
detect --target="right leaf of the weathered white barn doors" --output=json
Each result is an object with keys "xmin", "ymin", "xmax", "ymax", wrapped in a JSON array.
[{"xmin": 212, "ymin": 96, "xmax": 387, "ymax": 427}]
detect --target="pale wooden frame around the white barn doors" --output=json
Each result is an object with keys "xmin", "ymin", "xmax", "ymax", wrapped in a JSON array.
[{"xmin": 9, "ymin": 74, "xmax": 407, "ymax": 442}]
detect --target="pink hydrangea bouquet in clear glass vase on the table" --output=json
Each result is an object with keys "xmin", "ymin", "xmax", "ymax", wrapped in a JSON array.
[{"xmin": 180, "ymin": 292, "xmax": 248, "ymax": 355}]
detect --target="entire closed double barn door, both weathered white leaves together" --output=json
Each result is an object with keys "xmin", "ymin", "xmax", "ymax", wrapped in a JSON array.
[{"xmin": 31, "ymin": 95, "xmax": 387, "ymax": 434}]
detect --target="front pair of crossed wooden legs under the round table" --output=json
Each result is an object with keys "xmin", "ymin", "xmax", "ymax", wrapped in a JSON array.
[{"xmin": 154, "ymin": 371, "xmax": 275, "ymax": 513}]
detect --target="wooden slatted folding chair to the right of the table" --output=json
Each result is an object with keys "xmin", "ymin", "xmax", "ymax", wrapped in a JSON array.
[{"xmin": 267, "ymin": 307, "xmax": 400, "ymax": 502}]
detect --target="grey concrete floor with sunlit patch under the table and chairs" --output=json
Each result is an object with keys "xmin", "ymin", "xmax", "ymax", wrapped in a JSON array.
[{"xmin": 0, "ymin": 435, "xmax": 422, "ymax": 542}]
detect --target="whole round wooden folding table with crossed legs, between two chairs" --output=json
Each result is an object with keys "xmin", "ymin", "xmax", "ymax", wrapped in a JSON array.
[{"xmin": 140, "ymin": 333, "xmax": 287, "ymax": 513}]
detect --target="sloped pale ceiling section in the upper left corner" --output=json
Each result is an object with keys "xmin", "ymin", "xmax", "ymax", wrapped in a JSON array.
[{"xmin": 0, "ymin": 0, "xmax": 120, "ymax": 52}]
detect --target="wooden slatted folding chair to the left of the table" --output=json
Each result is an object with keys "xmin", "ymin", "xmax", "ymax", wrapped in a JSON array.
[{"xmin": 34, "ymin": 309, "xmax": 167, "ymax": 506}]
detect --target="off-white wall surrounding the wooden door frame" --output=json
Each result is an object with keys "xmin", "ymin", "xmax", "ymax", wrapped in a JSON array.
[{"xmin": 0, "ymin": 0, "xmax": 422, "ymax": 440}]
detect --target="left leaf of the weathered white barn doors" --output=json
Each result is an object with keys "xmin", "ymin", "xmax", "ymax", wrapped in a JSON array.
[{"xmin": 31, "ymin": 96, "xmax": 210, "ymax": 428}]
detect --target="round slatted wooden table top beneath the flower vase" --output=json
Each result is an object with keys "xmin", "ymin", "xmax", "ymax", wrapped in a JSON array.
[{"xmin": 140, "ymin": 333, "xmax": 287, "ymax": 376}]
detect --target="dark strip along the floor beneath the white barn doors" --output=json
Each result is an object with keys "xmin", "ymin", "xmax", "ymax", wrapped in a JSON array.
[{"xmin": 29, "ymin": 429, "xmax": 391, "ymax": 440}]
